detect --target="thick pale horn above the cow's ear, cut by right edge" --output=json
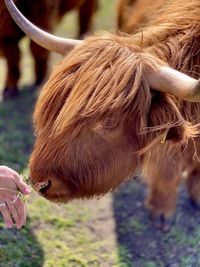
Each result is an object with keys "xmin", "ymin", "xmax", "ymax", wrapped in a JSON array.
[{"xmin": 147, "ymin": 67, "xmax": 200, "ymax": 102}]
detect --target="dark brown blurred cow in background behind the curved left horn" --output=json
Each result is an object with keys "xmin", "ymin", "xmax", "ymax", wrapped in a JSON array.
[{"xmin": 0, "ymin": 0, "xmax": 97, "ymax": 98}]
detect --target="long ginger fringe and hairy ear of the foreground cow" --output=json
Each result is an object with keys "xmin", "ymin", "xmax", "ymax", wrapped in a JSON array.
[{"xmin": 34, "ymin": 29, "xmax": 198, "ymax": 161}]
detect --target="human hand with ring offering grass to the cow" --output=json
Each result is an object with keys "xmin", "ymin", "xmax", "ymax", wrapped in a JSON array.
[{"xmin": 0, "ymin": 166, "xmax": 31, "ymax": 229}]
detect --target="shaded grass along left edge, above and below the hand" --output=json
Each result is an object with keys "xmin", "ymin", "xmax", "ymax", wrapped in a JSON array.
[{"xmin": 0, "ymin": 88, "xmax": 44, "ymax": 267}]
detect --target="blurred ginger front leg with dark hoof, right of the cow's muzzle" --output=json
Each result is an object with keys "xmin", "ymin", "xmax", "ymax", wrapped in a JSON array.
[{"xmin": 145, "ymin": 161, "xmax": 181, "ymax": 231}]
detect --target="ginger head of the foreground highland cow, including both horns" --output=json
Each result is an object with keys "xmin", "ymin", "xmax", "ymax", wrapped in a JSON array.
[{"xmin": 6, "ymin": 0, "xmax": 200, "ymax": 202}]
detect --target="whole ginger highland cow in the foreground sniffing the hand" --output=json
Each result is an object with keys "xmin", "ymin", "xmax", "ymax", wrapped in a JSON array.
[{"xmin": 6, "ymin": 0, "xmax": 200, "ymax": 230}]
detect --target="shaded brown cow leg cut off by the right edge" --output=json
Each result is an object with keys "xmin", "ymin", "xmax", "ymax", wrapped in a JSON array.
[{"xmin": 186, "ymin": 165, "xmax": 200, "ymax": 210}]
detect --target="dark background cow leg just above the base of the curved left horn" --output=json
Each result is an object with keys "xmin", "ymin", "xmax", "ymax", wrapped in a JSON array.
[{"xmin": 78, "ymin": 0, "xmax": 98, "ymax": 39}]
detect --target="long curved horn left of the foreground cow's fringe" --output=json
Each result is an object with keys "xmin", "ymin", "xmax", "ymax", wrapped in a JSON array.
[{"xmin": 5, "ymin": 0, "xmax": 82, "ymax": 55}]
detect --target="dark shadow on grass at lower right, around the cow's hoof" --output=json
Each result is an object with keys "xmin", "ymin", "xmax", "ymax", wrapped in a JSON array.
[{"xmin": 113, "ymin": 181, "xmax": 200, "ymax": 267}]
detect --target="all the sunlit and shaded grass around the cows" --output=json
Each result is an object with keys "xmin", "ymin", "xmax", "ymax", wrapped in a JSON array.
[{"xmin": 0, "ymin": 0, "xmax": 200, "ymax": 267}]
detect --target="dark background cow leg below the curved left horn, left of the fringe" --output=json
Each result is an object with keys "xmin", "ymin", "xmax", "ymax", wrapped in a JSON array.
[{"xmin": 30, "ymin": 41, "xmax": 49, "ymax": 86}]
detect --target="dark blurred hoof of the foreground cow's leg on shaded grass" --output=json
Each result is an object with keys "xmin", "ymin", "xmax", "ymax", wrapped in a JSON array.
[{"xmin": 149, "ymin": 214, "xmax": 173, "ymax": 232}]
